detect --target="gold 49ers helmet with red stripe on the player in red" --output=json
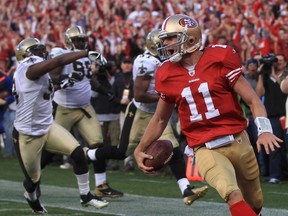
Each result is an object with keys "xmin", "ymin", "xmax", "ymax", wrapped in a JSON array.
[{"xmin": 157, "ymin": 14, "xmax": 202, "ymax": 62}]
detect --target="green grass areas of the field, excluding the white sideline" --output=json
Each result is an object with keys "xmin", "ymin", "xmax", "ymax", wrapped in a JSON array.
[{"xmin": 0, "ymin": 155, "xmax": 288, "ymax": 215}]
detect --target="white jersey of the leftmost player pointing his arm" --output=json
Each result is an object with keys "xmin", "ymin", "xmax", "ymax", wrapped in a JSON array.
[{"xmin": 13, "ymin": 56, "xmax": 54, "ymax": 136}]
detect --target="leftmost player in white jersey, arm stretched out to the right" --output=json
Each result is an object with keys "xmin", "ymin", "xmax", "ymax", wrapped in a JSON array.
[{"xmin": 13, "ymin": 38, "xmax": 108, "ymax": 214}]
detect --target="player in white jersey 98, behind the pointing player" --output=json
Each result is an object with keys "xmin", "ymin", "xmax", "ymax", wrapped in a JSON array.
[{"xmin": 50, "ymin": 26, "xmax": 123, "ymax": 198}]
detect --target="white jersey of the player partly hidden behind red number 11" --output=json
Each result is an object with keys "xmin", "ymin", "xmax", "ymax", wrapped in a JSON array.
[{"xmin": 133, "ymin": 51, "xmax": 161, "ymax": 113}]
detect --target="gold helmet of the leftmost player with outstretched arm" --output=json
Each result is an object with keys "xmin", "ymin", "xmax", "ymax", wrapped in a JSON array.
[{"xmin": 15, "ymin": 38, "xmax": 48, "ymax": 63}]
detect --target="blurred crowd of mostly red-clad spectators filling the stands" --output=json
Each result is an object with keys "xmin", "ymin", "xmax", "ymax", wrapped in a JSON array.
[{"xmin": 0, "ymin": 0, "xmax": 288, "ymax": 71}]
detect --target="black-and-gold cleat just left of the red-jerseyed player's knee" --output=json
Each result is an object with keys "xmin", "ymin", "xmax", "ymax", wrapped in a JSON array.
[{"xmin": 183, "ymin": 185, "xmax": 208, "ymax": 205}]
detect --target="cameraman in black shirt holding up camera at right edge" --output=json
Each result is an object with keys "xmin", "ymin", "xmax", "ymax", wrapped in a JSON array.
[{"xmin": 256, "ymin": 53, "xmax": 288, "ymax": 184}]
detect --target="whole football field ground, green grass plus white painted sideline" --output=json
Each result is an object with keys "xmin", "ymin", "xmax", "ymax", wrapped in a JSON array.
[{"xmin": 0, "ymin": 155, "xmax": 288, "ymax": 216}]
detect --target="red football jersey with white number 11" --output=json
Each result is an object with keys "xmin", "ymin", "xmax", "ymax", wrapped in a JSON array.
[{"xmin": 155, "ymin": 45, "xmax": 246, "ymax": 147}]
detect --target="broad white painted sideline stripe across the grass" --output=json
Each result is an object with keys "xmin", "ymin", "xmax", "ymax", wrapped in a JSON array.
[{"xmin": 0, "ymin": 180, "xmax": 288, "ymax": 216}]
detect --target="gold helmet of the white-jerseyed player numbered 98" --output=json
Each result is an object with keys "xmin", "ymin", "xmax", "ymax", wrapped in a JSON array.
[{"xmin": 65, "ymin": 26, "xmax": 88, "ymax": 50}]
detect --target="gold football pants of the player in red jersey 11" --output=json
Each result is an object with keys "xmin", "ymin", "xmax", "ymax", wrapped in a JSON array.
[{"xmin": 194, "ymin": 132, "xmax": 263, "ymax": 209}]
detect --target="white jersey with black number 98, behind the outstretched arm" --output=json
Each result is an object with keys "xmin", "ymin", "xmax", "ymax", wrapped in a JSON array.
[{"xmin": 50, "ymin": 48, "xmax": 91, "ymax": 108}]
